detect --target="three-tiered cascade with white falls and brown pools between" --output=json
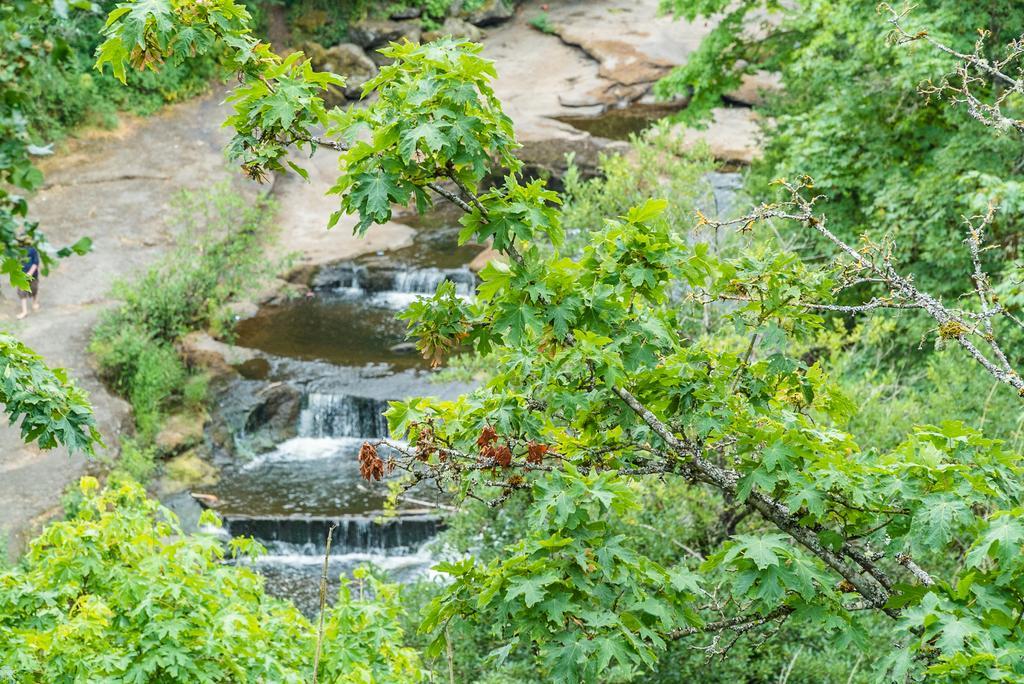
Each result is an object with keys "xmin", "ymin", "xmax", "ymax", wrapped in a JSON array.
[{"xmin": 222, "ymin": 211, "xmax": 477, "ymax": 610}]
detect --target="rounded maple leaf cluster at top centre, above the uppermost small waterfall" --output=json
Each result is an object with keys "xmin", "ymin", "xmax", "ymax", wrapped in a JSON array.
[{"xmin": 329, "ymin": 39, "xmax": 520, "ymax": 233}]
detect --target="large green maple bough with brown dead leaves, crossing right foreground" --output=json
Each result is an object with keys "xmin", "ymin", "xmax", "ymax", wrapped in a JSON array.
[{"xmin": 315, "ymin": 30, "xmax": 1021, "ymax": 679}]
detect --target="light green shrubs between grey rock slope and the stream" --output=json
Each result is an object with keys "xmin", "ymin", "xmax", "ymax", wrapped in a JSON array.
[{"xmin": 90, "ymin": 185, "xmax": 280, "ymax": 438}]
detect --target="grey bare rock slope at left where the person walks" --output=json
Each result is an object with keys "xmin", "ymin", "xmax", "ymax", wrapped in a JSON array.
[{"xmin": 0, "ymin": 93, "xmax": 245, "ymax": 553}]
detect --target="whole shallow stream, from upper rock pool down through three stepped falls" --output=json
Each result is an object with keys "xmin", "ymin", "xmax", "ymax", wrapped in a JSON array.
[{"xmin": 201, "ymin": 102, "xmax": 739, "ymax": 614}]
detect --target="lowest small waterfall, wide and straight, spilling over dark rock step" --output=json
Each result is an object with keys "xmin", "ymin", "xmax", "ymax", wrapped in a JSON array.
[{"xmin": 224, "ymin": 513, "xmax": 444, "ymax": 556}]
